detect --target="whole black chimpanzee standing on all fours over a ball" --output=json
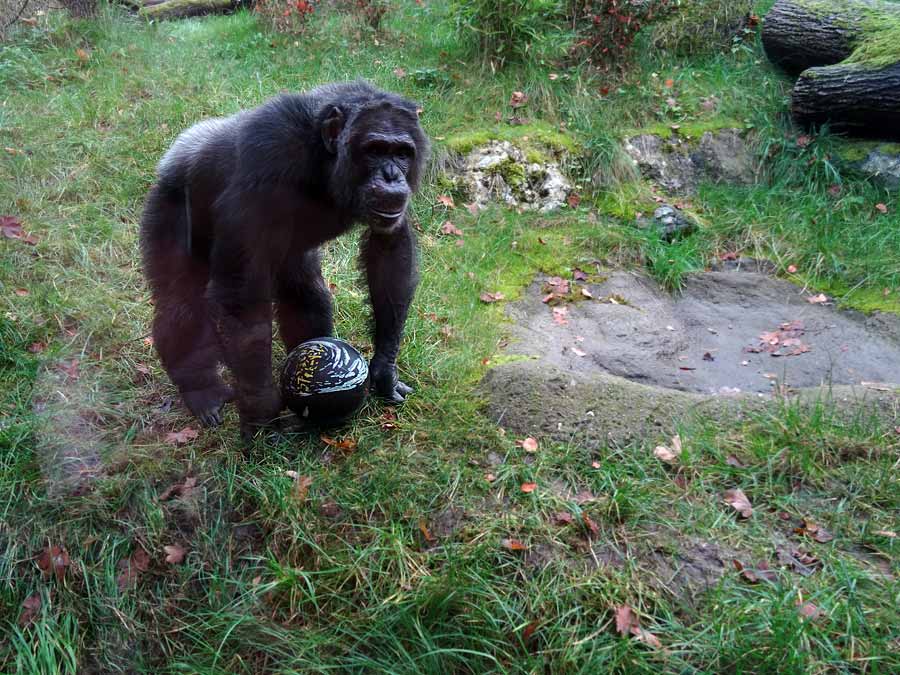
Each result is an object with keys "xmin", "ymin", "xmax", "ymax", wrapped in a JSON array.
[{"xmin": 141, "ymin": 82, "xmax": 429, "ymax": 436}]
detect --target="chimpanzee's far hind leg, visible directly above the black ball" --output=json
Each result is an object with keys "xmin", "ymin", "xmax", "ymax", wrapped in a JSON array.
[{"xmin": 276, "ymin": 250, "xmax": 334, "ymax": 352}]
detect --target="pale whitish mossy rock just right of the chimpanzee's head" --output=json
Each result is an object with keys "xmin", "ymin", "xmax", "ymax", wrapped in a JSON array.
[{"xmin": 452, "ymin": 141, "xmax": 572, "ymax": 212}]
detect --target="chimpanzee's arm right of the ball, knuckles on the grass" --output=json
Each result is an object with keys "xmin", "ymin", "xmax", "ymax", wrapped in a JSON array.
[{"xmin": 362, "ymin": 217, "xmax": 417, "ymax": 403}]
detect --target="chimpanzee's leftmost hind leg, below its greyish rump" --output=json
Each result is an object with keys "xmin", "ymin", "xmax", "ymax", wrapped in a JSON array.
[{"xmin": 141, "ymin": 186, "xmax": 233, "ymax": 426}]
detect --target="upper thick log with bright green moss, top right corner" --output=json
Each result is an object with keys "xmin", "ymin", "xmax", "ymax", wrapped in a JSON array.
[{"xmin": 762, "ymin": 0, "xmax": 900, "ymax": 74}]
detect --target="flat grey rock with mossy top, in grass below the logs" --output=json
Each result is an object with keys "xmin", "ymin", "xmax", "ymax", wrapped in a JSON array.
[{"xmin": 625, "ymin": 129, "xmax": 755, "ymax": 194}]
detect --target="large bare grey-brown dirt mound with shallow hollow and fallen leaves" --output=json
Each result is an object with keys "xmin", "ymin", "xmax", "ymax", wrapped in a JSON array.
[{"xmin": 482, "ymin": 271, "xmax": 900, "ymax": 442}]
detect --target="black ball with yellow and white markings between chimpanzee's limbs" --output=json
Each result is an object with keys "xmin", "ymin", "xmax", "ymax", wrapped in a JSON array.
[{"xmin": 281, "ymin": 337, "xmax": 369, "ymax": 425}]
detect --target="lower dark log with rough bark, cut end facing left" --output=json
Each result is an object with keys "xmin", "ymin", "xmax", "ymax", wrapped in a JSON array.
[{"xmin": 792, "ymin": 63, "xmax": 900, "ymax": 140}]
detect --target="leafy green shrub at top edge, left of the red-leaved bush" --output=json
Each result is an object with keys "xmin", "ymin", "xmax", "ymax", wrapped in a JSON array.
[{"xmin": 451, "ymin": 0, "xmax": 562, "ymax": 67}]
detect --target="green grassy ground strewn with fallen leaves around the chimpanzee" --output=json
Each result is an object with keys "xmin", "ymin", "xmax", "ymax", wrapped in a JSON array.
[{"xmin": 0, "ymin": 3, "xmax": 900, "ymax": 674}]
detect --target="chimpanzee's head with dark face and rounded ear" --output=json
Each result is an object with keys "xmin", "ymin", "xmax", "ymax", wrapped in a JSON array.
[{"xmin": 321, "ymin": 90, "xmax": 429, "ymax": 233}]
